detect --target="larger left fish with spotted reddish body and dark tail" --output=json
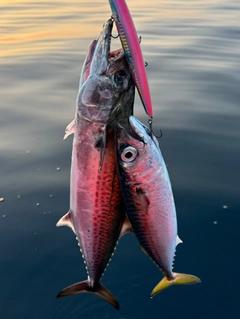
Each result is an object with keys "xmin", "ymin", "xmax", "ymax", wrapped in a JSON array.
[{"xmin": 57, "ymin": 19, "xmax": 135, "ymax": 309}]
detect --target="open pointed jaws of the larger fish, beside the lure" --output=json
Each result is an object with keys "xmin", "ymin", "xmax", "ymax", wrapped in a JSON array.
[{"xmin": 90, "ymin": 19, "xmax": 124, "ymax": 75}]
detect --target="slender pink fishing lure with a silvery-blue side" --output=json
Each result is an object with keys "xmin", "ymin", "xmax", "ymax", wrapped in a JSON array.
[{"xmin": 109, "ymin": 0, "xmax": 153, "ymax": 117}]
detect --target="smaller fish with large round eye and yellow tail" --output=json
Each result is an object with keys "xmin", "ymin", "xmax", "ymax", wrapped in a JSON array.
[{"xmin": 115, "ymin": 116, "xmax": 201, "ymax": 297}]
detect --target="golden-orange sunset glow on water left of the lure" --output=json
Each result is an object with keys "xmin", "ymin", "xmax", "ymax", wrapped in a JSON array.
[{"xmin": 0, "ymin": 0, "xmax": 110, "ymax": 57}]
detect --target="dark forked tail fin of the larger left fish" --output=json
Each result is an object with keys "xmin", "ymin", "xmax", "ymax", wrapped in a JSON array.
[{"xmin": 57, "ymin": 280, "xmax": 120, "ymax": 310}]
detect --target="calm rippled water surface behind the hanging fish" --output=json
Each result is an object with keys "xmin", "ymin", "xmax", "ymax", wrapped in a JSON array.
[{"xmin": 0, "ymin": 0, "xmax": 240, "ymax": 319}]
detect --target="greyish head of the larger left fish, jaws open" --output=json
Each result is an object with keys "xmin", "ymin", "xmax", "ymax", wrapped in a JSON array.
[{"xmin": 77, "ymin": 19, "xmax": 135, "ymax": 124}]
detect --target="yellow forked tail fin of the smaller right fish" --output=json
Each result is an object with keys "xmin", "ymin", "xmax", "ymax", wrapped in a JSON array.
[{"xmin": 150, "ymin": 273, "xmax": 201, "ymax": 298}]
